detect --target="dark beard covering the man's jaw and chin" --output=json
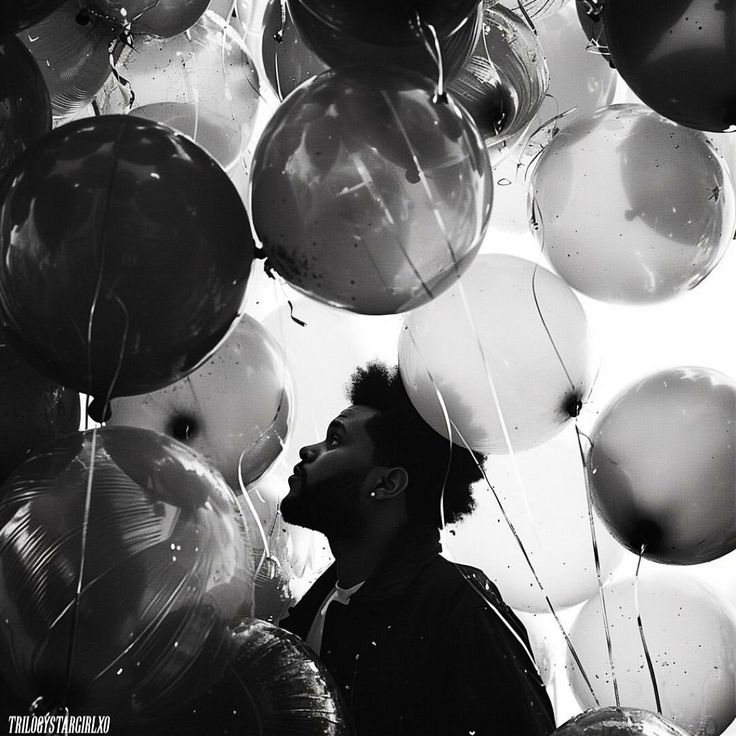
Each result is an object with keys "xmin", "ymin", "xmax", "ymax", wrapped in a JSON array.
[{"xmin": 281, "ymin": 484, "xmax": 363, "ymax": 541}]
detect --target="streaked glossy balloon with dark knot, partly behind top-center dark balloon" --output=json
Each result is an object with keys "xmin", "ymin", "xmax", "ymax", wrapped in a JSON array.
[{"xmin": 448, "ymin": 0, "xmax": 549, "ymax": 145}]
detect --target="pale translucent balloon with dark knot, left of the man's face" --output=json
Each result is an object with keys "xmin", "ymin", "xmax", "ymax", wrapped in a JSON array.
[{"xmin": 108, "ymin": 315, "xmax": 293, "ymax": 489}]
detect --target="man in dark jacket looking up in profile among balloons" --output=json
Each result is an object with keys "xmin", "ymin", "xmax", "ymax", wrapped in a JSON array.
[{"xmin": 281, "ymin": 363, "xmax": 554, "ymax": 736}]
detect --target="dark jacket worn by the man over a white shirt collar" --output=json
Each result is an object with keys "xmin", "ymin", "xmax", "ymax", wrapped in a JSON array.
[{"xmin": 281, "ymin": 527, "xmax": 555, "ymax": 736}]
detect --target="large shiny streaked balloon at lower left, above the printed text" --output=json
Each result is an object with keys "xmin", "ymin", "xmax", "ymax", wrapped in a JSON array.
[{"xmin": 0, "ymin": 427, "xmax": 253, "ymax": 721}]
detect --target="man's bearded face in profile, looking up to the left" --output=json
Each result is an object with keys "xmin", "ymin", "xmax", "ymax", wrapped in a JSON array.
[{"xmin": 281, "ymin": 406, "xmax": 378, "ymax": 538}]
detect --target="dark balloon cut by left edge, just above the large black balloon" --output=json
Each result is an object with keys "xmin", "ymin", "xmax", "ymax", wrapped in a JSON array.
[{"xmin": 0, "ymin": 36, "xmax": 51, "ymax": 177}]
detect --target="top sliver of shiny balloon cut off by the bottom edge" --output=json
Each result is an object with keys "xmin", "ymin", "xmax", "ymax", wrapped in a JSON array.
[{"xmin": 554, "ymin": 706, "xmax": 690, "ymax": 736}]
